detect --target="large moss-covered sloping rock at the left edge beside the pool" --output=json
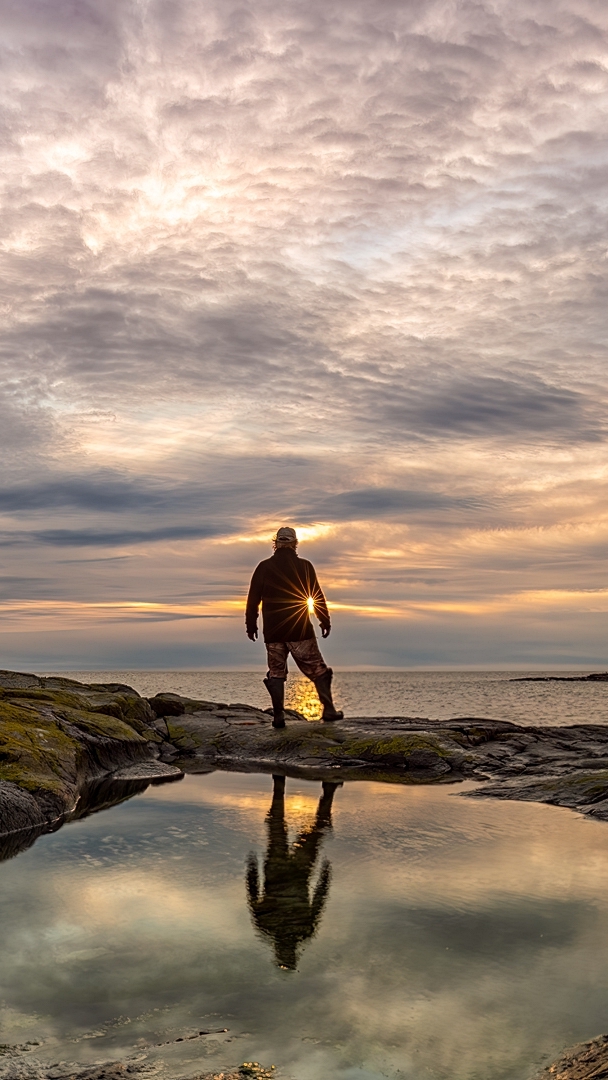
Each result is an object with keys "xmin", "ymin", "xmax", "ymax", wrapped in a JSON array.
[{"xmin": 0, "ymin": 671, "xmax": 183, "ymax": 858}]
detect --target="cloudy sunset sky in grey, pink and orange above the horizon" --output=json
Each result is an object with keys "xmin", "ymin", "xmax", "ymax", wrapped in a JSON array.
[{"xmin": 0, "ymin": 0, "xmax": 608, "ymax": 670}]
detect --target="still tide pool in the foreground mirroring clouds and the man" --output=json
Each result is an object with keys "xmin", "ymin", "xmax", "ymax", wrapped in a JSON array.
[{"xmin": 0, "ymin": 773, "xmax": 608, "ymax": 1080}]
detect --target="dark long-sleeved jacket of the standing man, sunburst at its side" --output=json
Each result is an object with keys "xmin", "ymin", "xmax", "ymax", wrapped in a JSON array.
[{"xmin": 245, "ymin": 548, "xmax": 330, "ymax": 642}]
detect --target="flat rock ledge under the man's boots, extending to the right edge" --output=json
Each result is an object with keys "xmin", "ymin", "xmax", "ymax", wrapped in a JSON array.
[{"xmin": 150, "ymin": 694, "xmax": 608, "ymax": 821}]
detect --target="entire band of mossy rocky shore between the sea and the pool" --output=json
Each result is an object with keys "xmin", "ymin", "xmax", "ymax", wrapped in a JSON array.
[{"xmin": 0, "ymin": 671, "xmax": 608, "ymax": 858}]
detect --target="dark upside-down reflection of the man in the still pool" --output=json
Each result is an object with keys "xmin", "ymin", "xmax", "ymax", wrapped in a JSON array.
[{"xmin": 247, "ymin": 777, "xmax": 340, "ymax": 971}]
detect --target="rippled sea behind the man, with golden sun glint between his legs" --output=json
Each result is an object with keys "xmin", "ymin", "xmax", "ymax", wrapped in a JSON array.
[{"xmin": 45, "ymin": 669, "xmax": 608, "ymax": 727}]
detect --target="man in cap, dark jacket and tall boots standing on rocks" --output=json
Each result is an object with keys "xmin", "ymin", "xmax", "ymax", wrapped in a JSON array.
[{"xmin": 245, "ymin": 527, "xmax": 343, "ymax": 728}]
